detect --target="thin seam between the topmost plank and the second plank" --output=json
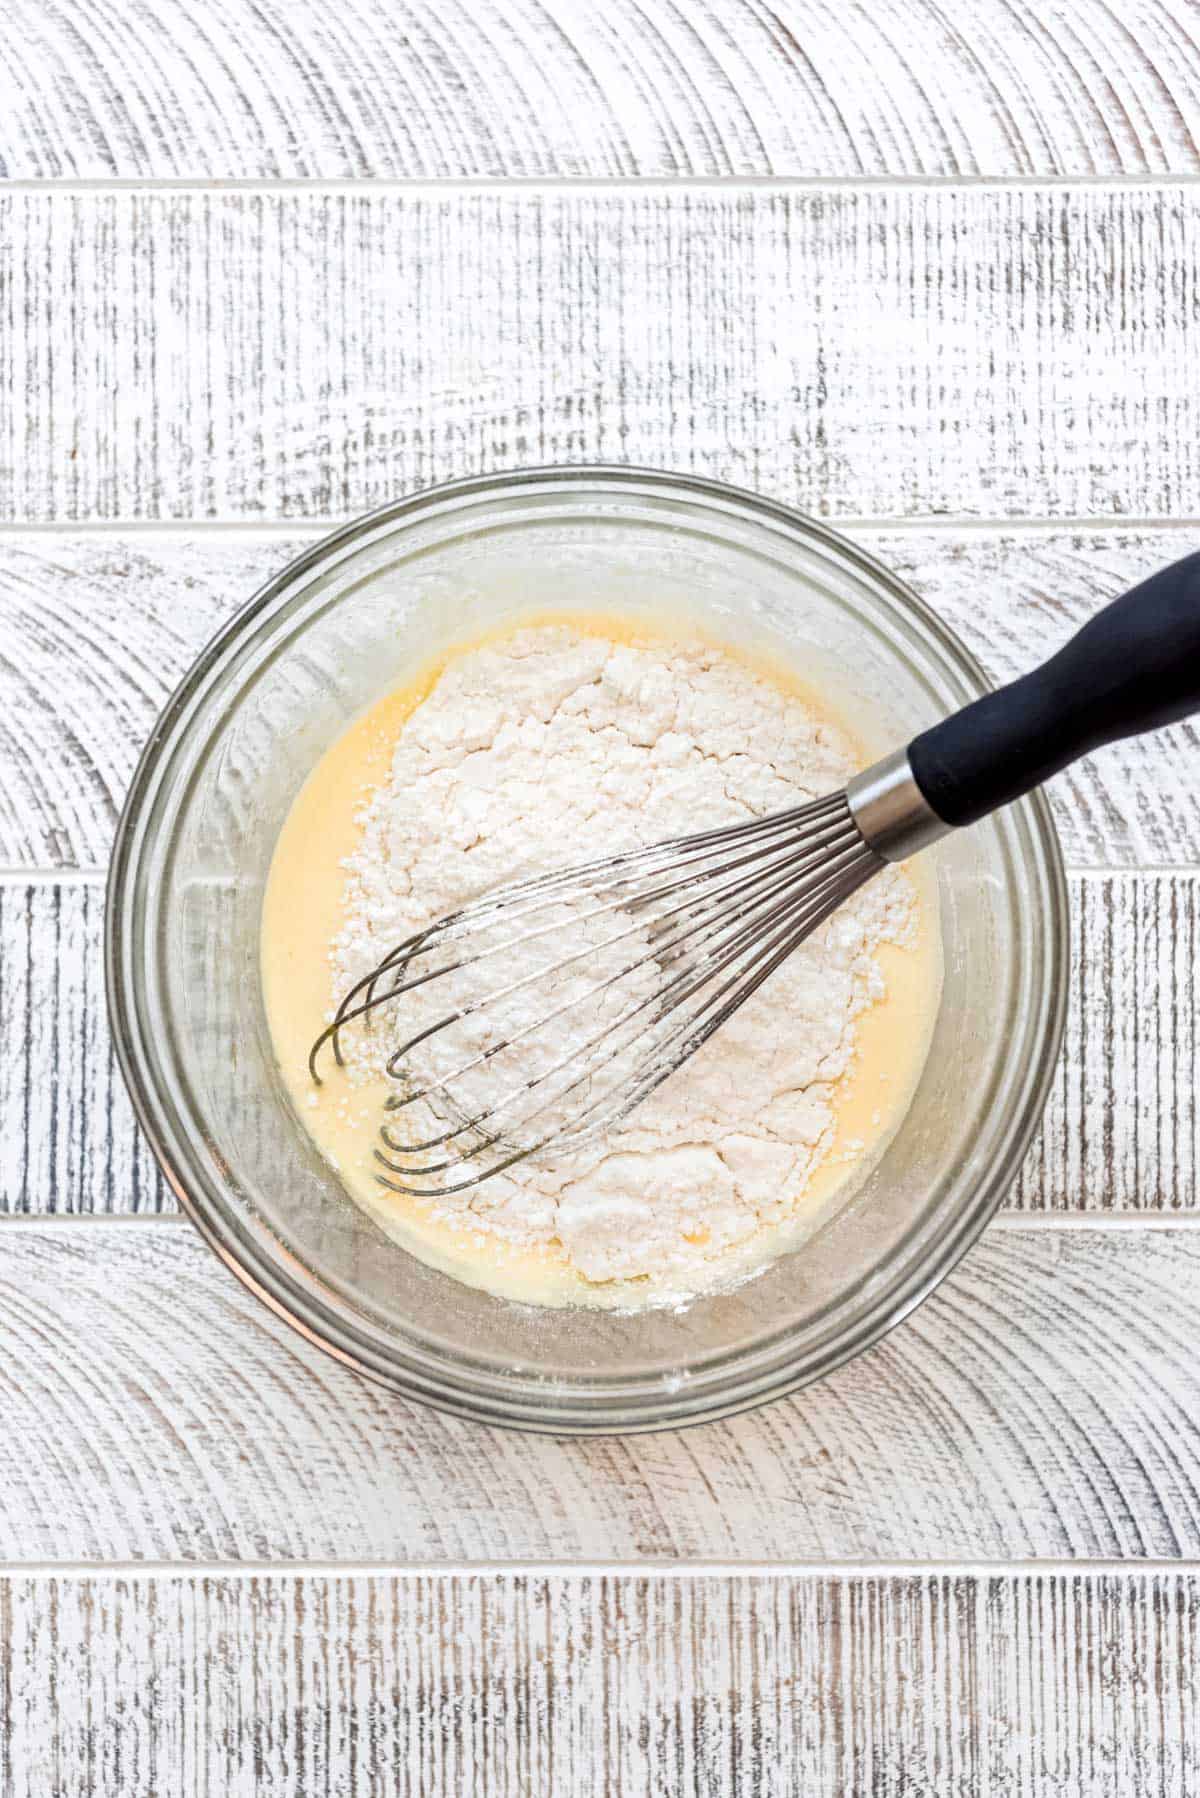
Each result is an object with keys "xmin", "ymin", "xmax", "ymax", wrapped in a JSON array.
[{"xmin": 0, "ymin": 169, "xmax": 1200, "ymax": 196}]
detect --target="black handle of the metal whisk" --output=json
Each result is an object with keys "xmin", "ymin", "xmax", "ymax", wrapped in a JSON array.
[{"xmin": 909, "ymin": 552, "xmax": 1200, "ymax": 825}]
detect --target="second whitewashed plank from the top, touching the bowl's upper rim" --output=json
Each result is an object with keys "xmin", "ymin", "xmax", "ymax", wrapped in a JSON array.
[{"xmin": 0, "ymin": 185, "xmax": 1200, "ymax": 521}]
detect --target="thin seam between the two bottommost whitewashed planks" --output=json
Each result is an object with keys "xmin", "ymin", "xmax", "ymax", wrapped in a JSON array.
[{"xmin": 0, "ymin": 1557, "xmax": 1200, "ymax": 1582}]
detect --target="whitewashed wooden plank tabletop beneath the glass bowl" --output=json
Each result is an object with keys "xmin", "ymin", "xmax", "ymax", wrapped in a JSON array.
[{"xmin": 0, "ymin": 0, "xmax": 1200, "ymax": 1798}]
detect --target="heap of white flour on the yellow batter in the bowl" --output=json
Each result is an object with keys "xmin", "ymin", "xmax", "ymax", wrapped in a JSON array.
[{"xmin": 333, "ymin": 626, "xmax": 916, "ymax": 1296}]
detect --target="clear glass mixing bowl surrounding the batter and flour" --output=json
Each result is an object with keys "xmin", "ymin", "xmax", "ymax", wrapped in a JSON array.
[{"xmin": 106, "ymin": 467, "xmax": 1067, "ymax": 1433}]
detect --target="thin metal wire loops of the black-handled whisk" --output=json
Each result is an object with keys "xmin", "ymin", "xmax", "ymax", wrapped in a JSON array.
[{"xmin": 309, "ymin": 795, "xmax": 882, "ymax": 1197}]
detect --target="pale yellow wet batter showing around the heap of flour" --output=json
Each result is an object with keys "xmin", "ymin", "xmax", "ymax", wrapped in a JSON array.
[{"xmin": 263, "ymin": 613, "xmax": 941, "ymax": 1307}]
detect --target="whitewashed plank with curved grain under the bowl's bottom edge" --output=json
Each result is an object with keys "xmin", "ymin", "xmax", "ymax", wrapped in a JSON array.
[{"xmin": 0, "ymin": 1221, "xmax": 1200, "ymax": 1566}]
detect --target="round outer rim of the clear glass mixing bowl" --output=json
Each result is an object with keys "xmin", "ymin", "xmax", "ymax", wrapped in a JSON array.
[{"xmin": 104, "ymin": 462, "xmax": 1070, "ymax": 1437}]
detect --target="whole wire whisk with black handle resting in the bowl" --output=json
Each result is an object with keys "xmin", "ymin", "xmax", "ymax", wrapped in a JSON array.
[{"xmin": 309, "ymin": 552, "xmax": 1200, "ymax": 1197}]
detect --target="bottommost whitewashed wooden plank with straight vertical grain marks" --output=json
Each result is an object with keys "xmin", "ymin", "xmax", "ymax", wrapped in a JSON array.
[{"xmin": 0, "ymin": 1573, "xmax": 1200, "ymax": 1798}]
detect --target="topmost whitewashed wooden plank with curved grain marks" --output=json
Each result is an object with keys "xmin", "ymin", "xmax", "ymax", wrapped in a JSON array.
[{"xmin": 0, "ymin": 0, "xmax": 1200, "ymax": 180}]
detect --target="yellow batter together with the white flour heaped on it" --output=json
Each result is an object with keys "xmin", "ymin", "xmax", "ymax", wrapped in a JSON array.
[{"xmin": 263, "ymin": 617, "xmax": 941, "ymax": 1307}]
